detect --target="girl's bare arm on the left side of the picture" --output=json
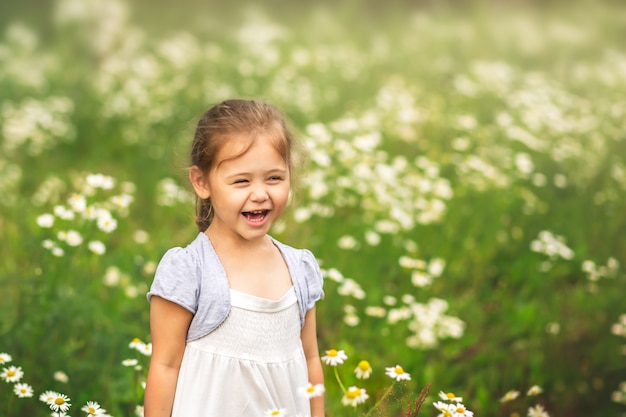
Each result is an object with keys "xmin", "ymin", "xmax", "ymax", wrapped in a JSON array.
[{"xmin": 144, "ymin": 296, "xmax": 193, "ymax": 417}]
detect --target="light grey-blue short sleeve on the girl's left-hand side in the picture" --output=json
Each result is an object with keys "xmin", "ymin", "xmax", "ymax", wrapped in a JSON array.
[{"xmin": 146, "ymin": 248, "xmax": 199, "ymax": 314}]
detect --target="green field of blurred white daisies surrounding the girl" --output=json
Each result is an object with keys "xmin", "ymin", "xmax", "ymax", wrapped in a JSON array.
[{"xmin": 0, "ymin": 0, "xmax": 626, "ymax": 417}]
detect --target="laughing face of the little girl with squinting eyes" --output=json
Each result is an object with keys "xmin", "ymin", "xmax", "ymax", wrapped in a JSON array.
[{"xmin": 197, "ymin": 133, "xmax": 291, "ymax": 241}]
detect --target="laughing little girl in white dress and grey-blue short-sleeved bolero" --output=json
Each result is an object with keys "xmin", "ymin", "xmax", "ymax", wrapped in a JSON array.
[{"xmin": 145, "ymin": 100, "xmax": 324, "ymax": 417}]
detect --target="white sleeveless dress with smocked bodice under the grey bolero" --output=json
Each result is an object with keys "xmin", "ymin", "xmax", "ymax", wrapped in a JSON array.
[{"xmin": 172, "ymin": 287, "xmax": 310, "ymax": 417}]
